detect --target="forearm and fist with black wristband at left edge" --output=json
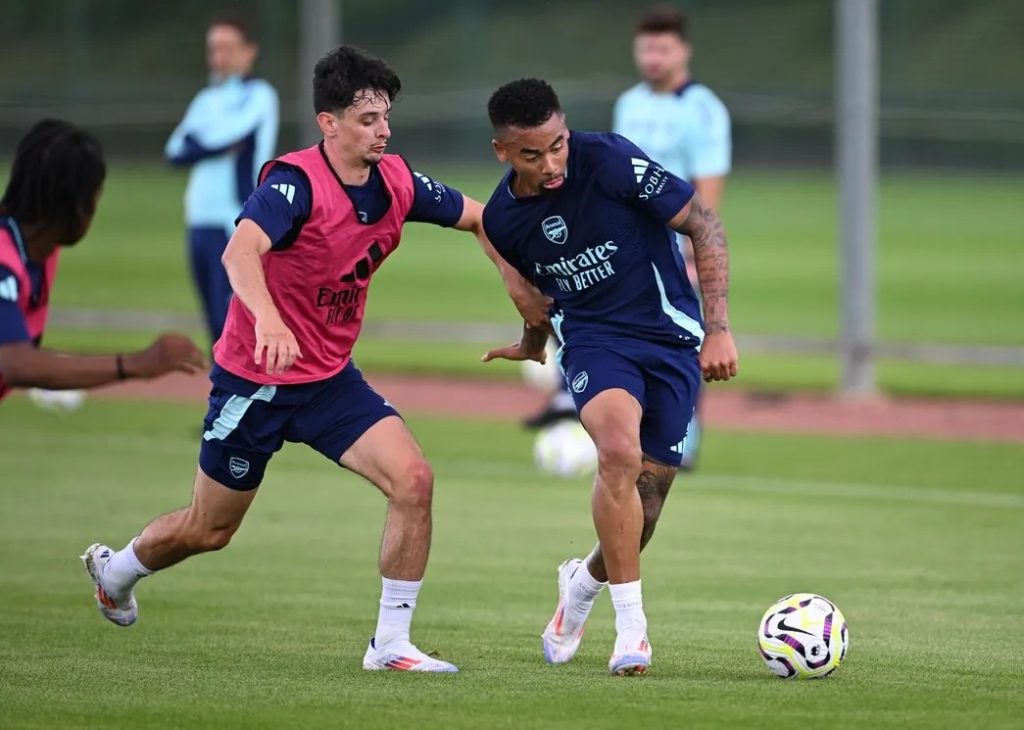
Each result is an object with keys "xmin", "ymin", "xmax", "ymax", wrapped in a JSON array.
[{"xmin": 0, "ymin": 333, "xmax": 206, "ymax": 390}]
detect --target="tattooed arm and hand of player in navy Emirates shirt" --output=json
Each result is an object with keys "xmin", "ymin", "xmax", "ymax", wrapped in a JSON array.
[{"xmin": 669, "ymin": 195, "xmax": 739, "ymax": 381}]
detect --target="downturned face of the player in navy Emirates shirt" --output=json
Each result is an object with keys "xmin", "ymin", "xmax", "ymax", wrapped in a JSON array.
[{"xmin": 492, "ymin": 112, "xmax": 569, "ymax": 196}]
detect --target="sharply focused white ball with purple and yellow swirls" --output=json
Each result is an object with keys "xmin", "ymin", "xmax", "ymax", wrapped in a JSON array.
[{"xmin": 758, "ymin": 593, "xmax": 850, "ymax": 679}]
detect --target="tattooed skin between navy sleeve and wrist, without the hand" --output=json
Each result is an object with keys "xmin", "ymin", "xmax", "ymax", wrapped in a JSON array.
[{"xmin": 679, "ymin": 197, "xmax": 729, "ymax": 334}]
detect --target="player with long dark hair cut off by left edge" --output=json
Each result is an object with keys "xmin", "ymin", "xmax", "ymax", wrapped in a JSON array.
[{"xmin": 0, "ymin": 119, "xmax": 204, "ymax": 399}]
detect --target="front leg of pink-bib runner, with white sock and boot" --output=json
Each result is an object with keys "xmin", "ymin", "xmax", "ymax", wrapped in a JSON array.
[{"xmin": 341, "ymin": 416, "xmax": 458, "ymax": 672}]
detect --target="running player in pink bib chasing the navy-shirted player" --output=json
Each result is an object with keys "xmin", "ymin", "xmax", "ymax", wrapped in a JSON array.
[{"xmin": 82, "ymin": 46, "xmax": 543, "ymax": 672}]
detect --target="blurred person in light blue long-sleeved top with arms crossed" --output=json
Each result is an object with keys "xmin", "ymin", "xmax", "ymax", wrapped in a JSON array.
[{"xmin": 164, "ymin": 13, "xmax": 279, "ymax": 342}]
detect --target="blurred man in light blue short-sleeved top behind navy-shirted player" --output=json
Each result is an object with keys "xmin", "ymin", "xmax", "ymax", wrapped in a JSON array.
[{"xmin": 526, "ymin": 5, "xmax": 732, "ymax": 469}]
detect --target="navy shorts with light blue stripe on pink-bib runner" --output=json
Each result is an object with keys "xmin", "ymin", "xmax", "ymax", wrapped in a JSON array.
[{"xmin": 199, "ymin": 361, "xmax": 398, "ymax": 490}]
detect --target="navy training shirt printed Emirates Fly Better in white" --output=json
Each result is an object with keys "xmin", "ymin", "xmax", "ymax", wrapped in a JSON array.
[{"xmin": 483, "ymin": 132, "xmax": 703, "ymax": 347}]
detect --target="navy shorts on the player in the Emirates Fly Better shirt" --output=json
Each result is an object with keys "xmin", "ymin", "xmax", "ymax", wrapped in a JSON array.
[{"xmin": 559, "ymin": 339, "xmax": 700, "ymax": 467}]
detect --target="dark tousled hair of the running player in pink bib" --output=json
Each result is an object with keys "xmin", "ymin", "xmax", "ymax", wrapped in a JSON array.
[{"xmin": 313, "ymin": 46, "xmax": 401, "ymax": 114}]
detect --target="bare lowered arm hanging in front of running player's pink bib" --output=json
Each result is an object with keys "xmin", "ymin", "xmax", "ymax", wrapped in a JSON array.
[{"xmin": 220, "ymin": 218, "xmax": 302, "ymax": 375}]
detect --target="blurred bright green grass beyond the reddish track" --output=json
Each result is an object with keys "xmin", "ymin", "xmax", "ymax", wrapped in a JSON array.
[{"xmin": 46, "ymin": 160, "xmax": 1024, "ymax": 397}]
